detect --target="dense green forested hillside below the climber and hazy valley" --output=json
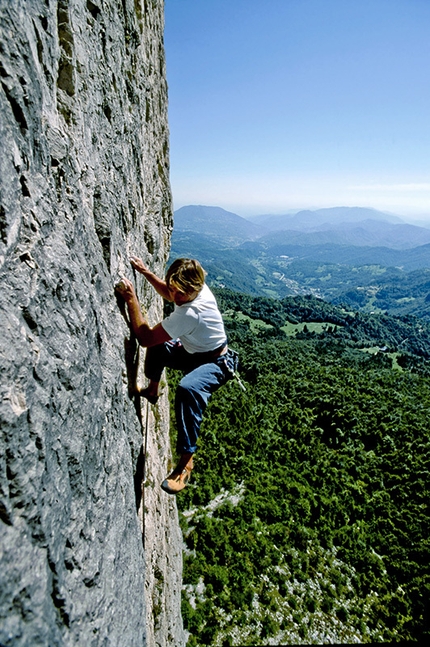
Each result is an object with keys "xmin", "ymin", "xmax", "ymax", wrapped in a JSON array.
[{"xmin": 170, "ymin": 290, "xmax": 430, "ymax": 646}]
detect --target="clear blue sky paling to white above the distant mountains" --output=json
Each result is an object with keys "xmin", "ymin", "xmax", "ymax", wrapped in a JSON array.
[{"xmin": 165, "ymin": 0, "xmax": 430, "ymax": 217}]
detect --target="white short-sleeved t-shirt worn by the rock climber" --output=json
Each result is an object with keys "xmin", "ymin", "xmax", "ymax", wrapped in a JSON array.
[{"xmin": 161, "ymin": 284, "xmax": 227, "ymax": 353}]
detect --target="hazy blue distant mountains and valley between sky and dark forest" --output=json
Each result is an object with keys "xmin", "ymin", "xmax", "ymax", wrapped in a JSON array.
[{"xmin": 171, "ymin": 205, "xmax": 430, "ymax": 319}]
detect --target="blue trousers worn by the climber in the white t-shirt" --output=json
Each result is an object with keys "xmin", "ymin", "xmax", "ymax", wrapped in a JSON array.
[{"xmin": 145, "ymin": 340, "xmax": 234, "ymax": 454}]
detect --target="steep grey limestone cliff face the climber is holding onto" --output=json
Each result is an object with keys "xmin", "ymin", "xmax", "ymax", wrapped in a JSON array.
[{"xmin": 0, "ymin": 0, "xmax": 184, "ymax": 647}]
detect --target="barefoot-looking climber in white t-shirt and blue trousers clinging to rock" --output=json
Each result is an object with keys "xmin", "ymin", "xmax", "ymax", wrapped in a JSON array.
[{"xmin": 116, "ymin": 256, "xmax": 235, "ymax": 494}]
